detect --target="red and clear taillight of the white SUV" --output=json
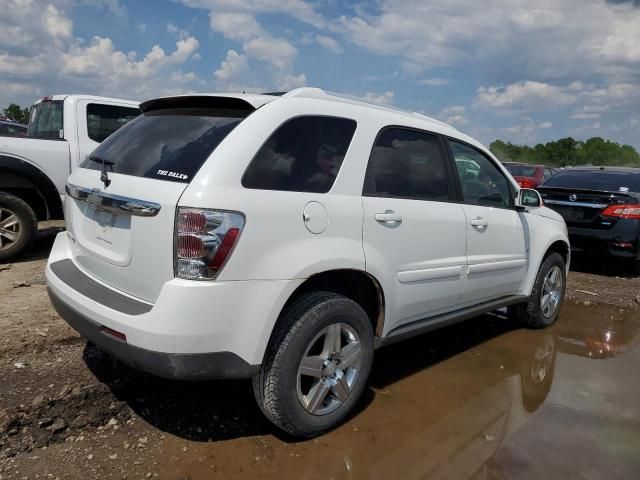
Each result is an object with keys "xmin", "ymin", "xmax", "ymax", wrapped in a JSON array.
[{"xmin": 175, "ymin": 207, "xmax": 244, "ymax": 280}]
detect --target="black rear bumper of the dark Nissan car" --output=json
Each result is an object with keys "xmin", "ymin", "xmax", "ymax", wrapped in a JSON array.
[{"xmin": 569, "ymin": 224, "xmax": 640, "ymax": 259}]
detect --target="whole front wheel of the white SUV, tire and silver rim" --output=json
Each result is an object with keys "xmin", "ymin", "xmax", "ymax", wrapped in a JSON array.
[{"xmin": 509, "ymin": 252, "xmax": 567, "ymax": 328}]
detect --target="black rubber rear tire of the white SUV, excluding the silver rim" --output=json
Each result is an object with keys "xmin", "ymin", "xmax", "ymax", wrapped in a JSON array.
[{"xmin": 253, "ymin": 292, "xmax": 373, "ymax": 437}]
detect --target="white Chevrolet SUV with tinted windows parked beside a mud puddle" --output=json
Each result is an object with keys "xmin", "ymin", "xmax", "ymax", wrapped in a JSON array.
[{"xmin": 47, "ymin": 88, "xmax": 569, "ymax": 436}]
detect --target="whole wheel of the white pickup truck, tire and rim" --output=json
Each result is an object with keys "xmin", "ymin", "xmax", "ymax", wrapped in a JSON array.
[{"xmin": 0, "ymin": 192, "xmax": 38, "ymax": 262}]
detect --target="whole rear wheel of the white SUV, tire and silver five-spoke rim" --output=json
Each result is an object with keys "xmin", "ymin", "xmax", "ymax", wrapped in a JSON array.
[{"xmin": 253, "ymin": 292, "xmax": 373, "ymax": 437}]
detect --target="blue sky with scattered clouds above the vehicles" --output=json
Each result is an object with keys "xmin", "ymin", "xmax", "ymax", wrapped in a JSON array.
[{"xmin": 0, "ymin": 0, "xmax": 640, "ymax": 149}]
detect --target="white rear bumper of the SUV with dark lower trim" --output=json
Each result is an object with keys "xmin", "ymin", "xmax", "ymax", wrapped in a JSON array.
[{"xmin": 46, "ymin": 232, "xmax": 302, "ymax": 379}]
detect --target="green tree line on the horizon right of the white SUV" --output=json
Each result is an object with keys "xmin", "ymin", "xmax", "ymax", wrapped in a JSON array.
[{"xmin": 489, "ymin": 137, "xmax": 640, "ymax": 167}]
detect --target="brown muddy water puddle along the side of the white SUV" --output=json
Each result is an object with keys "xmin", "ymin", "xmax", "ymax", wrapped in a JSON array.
[{"xmin": 159, "ymin": 304, "xmax": 640, "ymax": 479}]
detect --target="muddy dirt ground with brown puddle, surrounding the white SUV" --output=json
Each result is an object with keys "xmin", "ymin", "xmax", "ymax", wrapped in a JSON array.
[{"xmin": 0, "ymin": 227, "xmax": 640, "ymax": 480}]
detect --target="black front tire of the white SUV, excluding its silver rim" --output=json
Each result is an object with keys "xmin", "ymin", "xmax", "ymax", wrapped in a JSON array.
[{"xmin": 509, "ymin": 252, "xmax": 567, "ymax": 328}]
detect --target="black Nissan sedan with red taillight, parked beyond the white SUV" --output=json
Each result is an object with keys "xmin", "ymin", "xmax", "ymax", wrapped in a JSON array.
[{"xmin": 539, "ymin": 167, "xmax": 640, "ymax": 271}]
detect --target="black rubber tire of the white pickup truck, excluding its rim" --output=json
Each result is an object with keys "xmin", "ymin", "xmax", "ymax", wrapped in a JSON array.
[{"xmin": 0, "ymin": 192, "xmax": 38, "ymax": 262}]
